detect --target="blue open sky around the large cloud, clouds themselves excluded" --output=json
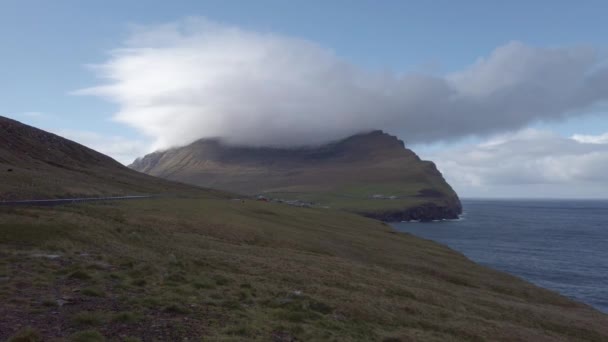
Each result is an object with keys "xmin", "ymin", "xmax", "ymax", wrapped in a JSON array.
[{"xmin": 0, "ymin": 0, "xmax": 608, "ymax": 197}]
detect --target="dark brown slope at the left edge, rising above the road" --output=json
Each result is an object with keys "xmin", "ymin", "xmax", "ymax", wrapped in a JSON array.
[{"xmin": 0, "ymin": 116, "xmax": 207, "ymax": 200}]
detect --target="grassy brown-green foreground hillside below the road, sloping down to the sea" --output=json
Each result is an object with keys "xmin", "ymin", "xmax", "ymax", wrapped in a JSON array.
[{"xmin": 0, "ymin": 195, "xmax": 608, "ymax": 341}]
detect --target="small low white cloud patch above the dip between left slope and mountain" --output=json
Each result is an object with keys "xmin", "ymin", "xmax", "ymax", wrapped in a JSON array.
[{"xmin": 51, "ymin": 129, "xmax": 151, "ymax": 165}]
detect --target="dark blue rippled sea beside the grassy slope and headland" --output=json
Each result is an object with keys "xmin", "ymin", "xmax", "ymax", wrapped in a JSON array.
[{"xmin": 394, "ymin": 200, "xmax": 608, "ymax": 313}]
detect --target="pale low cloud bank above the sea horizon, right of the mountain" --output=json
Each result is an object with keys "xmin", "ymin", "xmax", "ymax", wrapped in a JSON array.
[{"xmin": 425, "ymin": 129, "xmax": 608, "ymax": 198}]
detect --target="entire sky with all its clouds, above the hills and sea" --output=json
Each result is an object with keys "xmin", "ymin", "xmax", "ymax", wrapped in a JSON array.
[{"xmin": 0, "ymin": 0, "xmax": 608, "ymax": 198}]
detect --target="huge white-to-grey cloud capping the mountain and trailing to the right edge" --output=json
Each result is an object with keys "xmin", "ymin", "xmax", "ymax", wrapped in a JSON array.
[{"xmin": 77, "ymin": 18, "xmax": 608, "ymax": 148}]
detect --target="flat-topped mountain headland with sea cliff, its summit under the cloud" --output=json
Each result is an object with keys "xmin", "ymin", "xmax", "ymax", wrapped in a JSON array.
[{"xmin": 130, "ymin": 131, "xmax": 462, "ymax": 221}]
